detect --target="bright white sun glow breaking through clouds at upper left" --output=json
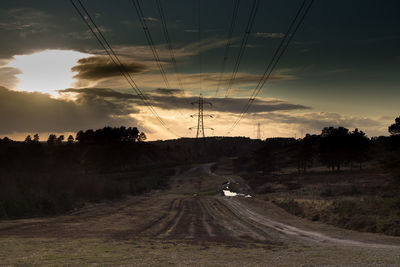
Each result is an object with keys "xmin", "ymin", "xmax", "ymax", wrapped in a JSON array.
[{"xmin": 9, "ymin": 50, "xmax": 91, "ymax": 96}]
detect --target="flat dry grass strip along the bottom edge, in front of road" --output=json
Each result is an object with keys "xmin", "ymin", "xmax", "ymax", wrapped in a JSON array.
[{"xmin": 0, "ymin": 238, "xmax": 400, "ymax": 266}]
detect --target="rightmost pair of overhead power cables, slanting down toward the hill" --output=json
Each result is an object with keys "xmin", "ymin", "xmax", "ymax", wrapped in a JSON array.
[{"xmin": 227, "ymin": 0, "xmax": 314, "ymax": 134}]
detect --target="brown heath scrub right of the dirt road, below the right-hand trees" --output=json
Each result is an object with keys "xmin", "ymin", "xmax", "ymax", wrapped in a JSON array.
[{"xmin": 239, "ymin": 169, "xmax": 400, "ymax": 236}]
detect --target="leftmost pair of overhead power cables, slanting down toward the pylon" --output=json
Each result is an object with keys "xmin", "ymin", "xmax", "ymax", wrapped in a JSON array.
[{"xmin": 70, "ymin": 0, "xmax": 179, "ymax": 137}]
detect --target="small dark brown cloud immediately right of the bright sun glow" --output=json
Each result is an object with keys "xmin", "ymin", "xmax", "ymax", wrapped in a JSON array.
[{"xmin": 71, "ymin": 56, "xmax": 147, "ymax": 80}]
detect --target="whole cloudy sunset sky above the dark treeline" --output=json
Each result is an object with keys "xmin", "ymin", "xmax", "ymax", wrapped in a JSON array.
[{"xmin": 0, "ymin": 0, "xmax": 400, "ymax": 140}]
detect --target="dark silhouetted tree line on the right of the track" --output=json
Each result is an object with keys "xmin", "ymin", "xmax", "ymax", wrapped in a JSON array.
[{"xmin": 247, "ymin": 117, "xmax": 400, "ymax": 176}]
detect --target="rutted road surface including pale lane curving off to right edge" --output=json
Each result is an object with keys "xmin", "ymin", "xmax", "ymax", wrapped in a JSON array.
[{"xmin": 142, "ymin": 197, "xmax": 399, "ymax": 248}]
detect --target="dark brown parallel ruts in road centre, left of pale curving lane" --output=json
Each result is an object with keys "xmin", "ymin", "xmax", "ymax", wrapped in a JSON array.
[{"xmin": 142, "ymin": 197, "xmax": 280, "ymax": 245}]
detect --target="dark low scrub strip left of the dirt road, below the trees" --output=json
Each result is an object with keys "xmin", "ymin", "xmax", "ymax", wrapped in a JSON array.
[{"xmin": 0, "ymin": 164, "xmax": 175, "ymax": 220}]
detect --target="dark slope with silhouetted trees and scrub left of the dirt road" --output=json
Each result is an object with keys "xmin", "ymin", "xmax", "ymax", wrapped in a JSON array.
[{"xmin": 0, "ymin": 127, "xmax": 160, "ymax": 218}]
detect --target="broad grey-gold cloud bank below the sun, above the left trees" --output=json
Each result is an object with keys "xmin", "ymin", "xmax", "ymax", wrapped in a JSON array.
[{"xmin": 0, "ymin": 87, "xmax": 138, "ymax": 134}]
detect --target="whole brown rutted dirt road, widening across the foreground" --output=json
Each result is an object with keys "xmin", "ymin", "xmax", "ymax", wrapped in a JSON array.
[{"xmin": 0, "ymin": 164, "xmax": 400, "ymax": 264}]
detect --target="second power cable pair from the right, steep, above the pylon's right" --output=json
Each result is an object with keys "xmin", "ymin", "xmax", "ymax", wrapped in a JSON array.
[{"xmin": 225, "ymin": 0, "xmax": 260, "ymax": 97}]
